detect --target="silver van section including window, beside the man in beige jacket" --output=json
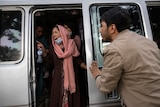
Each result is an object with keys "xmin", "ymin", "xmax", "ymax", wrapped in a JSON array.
[{"xmin": 83, "ymin": 0, "xmax": 152, "ymax": 107}]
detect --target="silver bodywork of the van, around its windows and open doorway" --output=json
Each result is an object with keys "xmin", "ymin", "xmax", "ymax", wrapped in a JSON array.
[{"xmin": 0, "ymin": 0, "xmax": 160, "ymax": 107}]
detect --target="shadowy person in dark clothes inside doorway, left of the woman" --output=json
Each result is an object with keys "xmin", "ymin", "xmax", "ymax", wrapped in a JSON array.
[{"xmin": 35, "ymin": 25, "xmax": 49, "ymax": 96}]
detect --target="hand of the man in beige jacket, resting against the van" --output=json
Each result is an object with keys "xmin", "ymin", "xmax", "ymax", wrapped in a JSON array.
[{"xmin": 89, "ymin": 61, "xmax": 101, "ymax": 79}]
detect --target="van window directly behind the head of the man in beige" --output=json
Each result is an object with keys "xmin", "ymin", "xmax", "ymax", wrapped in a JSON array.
[{"xmin": 90, "ymin": 4, "xmax": 145, "ymax": 100}]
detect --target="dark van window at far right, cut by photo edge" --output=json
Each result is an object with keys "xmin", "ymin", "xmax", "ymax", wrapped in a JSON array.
[{"xmin": 147, "ymin": 2, "xmax": 160, "ymax": 48}]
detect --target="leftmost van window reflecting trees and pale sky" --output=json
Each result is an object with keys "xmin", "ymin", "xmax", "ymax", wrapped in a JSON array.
[{"xmin": 0, "ymin": 10, "xmax": 22, "ymax": 63}]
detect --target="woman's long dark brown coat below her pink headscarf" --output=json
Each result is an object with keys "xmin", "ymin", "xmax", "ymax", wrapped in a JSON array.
[{"xmin": 49, "ymin": 46, "xmax": 81, "ymax": 107}]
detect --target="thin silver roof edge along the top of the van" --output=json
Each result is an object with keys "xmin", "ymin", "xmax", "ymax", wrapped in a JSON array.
[{"xmin": 0, "ymin": 0, "xmax": 159, "ymax": 6}]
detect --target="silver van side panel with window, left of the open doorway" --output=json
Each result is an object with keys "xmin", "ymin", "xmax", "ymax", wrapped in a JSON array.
[{"xmin": 0, "ymin": 6, "xmax": 29, "ymax": 107}]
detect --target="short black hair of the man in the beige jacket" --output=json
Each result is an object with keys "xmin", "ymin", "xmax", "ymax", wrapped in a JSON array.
[{"xmin": 101, "ymin": 7, "xmax": 131, "ymax": 32}]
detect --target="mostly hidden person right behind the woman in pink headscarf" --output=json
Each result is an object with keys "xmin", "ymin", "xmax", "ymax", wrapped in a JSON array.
[{"xmin": 64, "ymin": 21, "xmax": 88, "ymax": 107}]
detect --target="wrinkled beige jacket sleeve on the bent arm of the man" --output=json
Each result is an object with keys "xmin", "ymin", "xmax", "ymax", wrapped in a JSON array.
[{"xmin": 96, "ymin": 49, "xmax": 122, "ymax": 93}]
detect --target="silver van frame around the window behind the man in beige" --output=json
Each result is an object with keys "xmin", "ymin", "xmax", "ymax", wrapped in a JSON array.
[{"xmin": 82, "ymin": 0, "xmax": 153, "ymax": 107}]
